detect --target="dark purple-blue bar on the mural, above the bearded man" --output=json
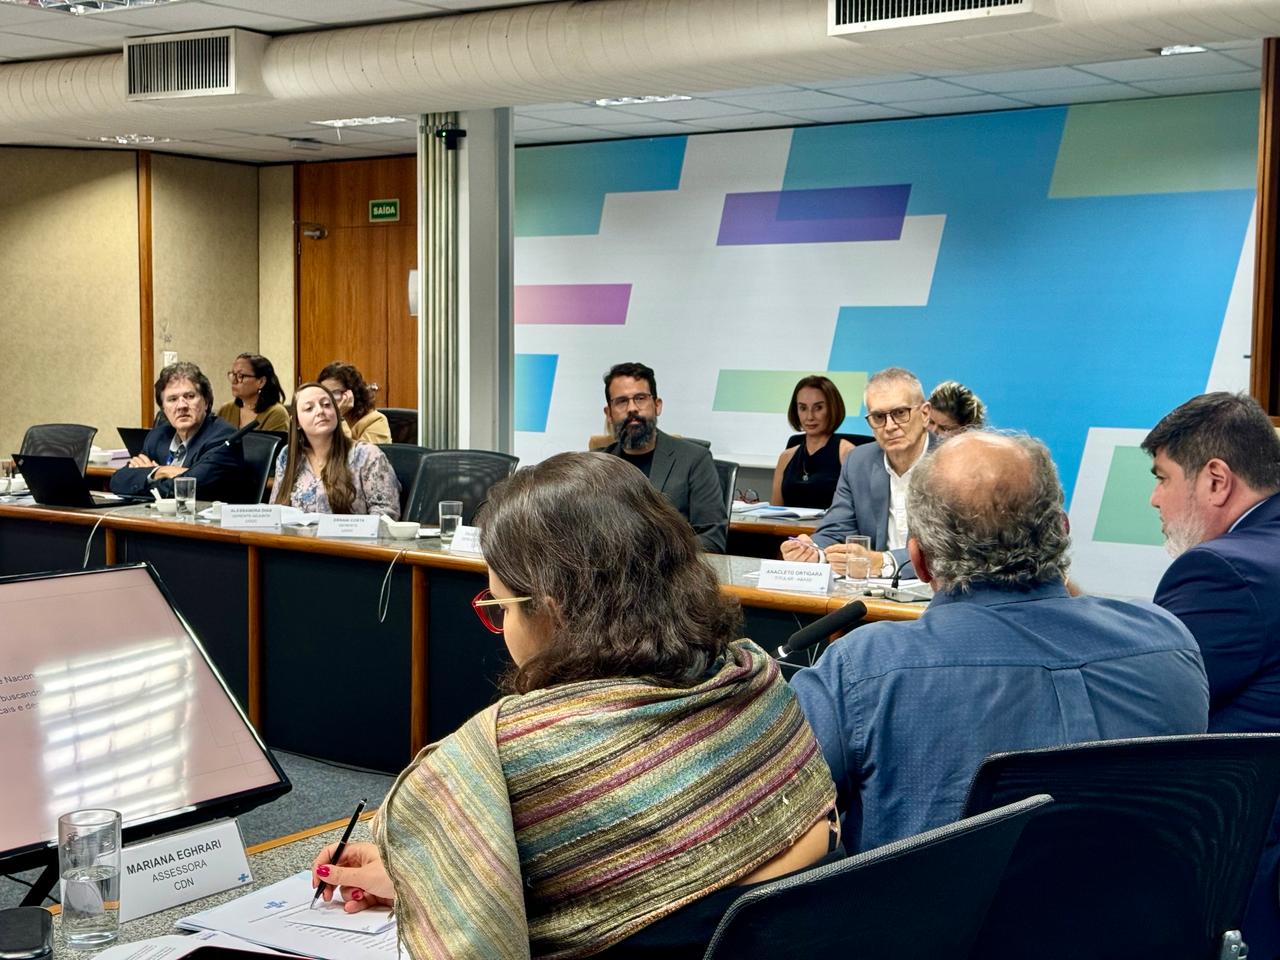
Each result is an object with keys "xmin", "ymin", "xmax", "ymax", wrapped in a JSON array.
[{"xmin": 716, "ymin": 183, "xmax": 911, "ymax": 246}]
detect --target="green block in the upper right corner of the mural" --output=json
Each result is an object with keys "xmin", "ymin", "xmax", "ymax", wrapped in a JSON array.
[{"xmin": 1048, "ymin": 90, "xmax": 1258, "ymax": 198}]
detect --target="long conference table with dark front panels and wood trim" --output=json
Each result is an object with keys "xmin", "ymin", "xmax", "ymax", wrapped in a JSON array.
[{"xmin": 0, "ymin": 503, "xmax": 924, "ymax": 772}]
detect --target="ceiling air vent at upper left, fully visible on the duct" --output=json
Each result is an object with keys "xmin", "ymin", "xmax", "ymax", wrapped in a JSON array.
[{"xmin": 124, "ymin": 29, "xmax": 268, "ymax": 100}]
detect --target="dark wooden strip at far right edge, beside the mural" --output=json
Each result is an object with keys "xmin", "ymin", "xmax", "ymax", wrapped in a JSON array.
[{"xmin": 1249, "ymin": 37, "xmax": 1280, "ymax": 425}]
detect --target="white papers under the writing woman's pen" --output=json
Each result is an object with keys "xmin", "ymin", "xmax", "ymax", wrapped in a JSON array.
[{"xmin": 178, "ymin": 870, "xmax": 399, "ymax": 960}]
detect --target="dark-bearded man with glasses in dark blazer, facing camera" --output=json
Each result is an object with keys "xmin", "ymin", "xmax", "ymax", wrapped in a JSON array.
[{"xmin": 604, "ymin": 364, "xmax": 728, "ymax": 553}]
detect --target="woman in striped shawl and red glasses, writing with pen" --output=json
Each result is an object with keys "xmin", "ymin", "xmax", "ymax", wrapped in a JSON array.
[{"xmin": 314, "ymin": 453, "xmax": 838, "ymax": 960}]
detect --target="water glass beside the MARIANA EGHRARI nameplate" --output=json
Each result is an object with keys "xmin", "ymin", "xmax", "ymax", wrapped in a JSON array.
[{"xmin": 58, "ymin": 809, "xmax": 120, "ymax": 947}]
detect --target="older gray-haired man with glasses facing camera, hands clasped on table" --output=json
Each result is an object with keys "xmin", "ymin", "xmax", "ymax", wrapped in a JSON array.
[{"xmin": 782, "ymin": 366, "xmax": 936, "ymax": 576}]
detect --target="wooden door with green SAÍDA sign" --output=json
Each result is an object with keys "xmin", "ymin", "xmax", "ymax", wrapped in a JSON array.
[{"xmin": 294, "ymin": 157, "xmax": 417, "ymax": 407}]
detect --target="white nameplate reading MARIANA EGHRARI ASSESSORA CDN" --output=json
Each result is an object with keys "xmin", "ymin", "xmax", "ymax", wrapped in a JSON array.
[{"xmin": 120, "ymin": 820, "xmax": 253, "ymax": 923}]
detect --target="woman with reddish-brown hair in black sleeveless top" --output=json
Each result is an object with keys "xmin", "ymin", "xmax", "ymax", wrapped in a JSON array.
[{"xmin": 769, "ymin": 376, "xmax": 854, "ymax": 509}]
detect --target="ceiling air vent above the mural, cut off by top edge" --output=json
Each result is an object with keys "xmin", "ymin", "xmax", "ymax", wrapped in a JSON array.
[{"xmin": 827, "ymin": 0, "xmax": 1057, "ymax": 44}]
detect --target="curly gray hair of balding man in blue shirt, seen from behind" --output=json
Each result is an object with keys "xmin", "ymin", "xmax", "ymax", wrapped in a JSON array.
[{"xmin": 908, "ymin": 430, "xmax": 1071, "ymax": 593}]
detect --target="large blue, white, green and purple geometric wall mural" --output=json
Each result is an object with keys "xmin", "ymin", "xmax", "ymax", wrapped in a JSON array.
[{"xmin": 516, "ymin": 91, "xmax": 1257, "ymax": 594}]
